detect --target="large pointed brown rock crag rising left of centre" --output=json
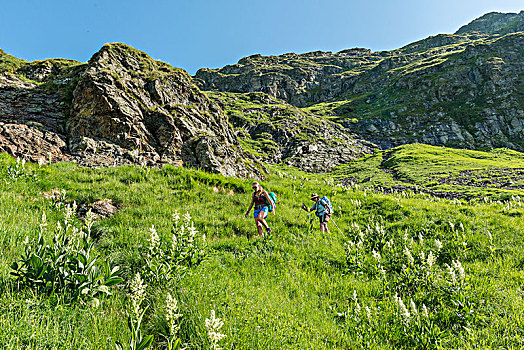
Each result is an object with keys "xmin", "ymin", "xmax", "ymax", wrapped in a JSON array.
[{"xmin": 67, "ymin": 44, "xmax": 255, "ymax": 176}]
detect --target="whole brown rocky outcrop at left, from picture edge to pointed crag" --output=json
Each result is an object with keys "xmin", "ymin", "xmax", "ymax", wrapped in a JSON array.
[{"xmin": 0, "ymin": 44, "xmax": 260, "ymax": 177}]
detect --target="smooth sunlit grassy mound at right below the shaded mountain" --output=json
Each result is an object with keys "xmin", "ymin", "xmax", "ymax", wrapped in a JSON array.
[{"xmin": 335, "ymin": 144, "xmax": 524, "ymax": 199}]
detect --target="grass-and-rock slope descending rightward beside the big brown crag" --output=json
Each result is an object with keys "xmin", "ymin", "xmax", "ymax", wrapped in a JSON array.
[{"xmin": 208, "ymin": 92, "xmax": 376, "ymax": 172}]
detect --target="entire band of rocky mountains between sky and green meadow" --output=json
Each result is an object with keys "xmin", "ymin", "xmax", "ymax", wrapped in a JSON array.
[{"xmin": 4, "ymin": 12, "xmax": 524, "ymax": 177}]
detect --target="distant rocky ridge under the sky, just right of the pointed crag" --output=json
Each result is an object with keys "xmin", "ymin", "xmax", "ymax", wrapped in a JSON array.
[{"xmin": 195, "ymin": 49, "xmax": 380, "ymax": 107}]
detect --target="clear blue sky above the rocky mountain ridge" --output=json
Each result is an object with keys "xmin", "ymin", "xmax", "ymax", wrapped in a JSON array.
[{"xmin": 0, "ymin": 0, "xmax": 524, "ymax": 74}]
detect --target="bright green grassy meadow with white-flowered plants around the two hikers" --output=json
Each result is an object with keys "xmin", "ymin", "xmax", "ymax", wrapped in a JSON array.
[{"xmin": 0, "ymin": 150, "xmax": 524, "ymax": 349}]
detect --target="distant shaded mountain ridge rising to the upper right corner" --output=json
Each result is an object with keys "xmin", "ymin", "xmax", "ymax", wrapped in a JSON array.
[{"xmin": 195, "ymin": 11, "xmax": 524, "ymax": 151}]
